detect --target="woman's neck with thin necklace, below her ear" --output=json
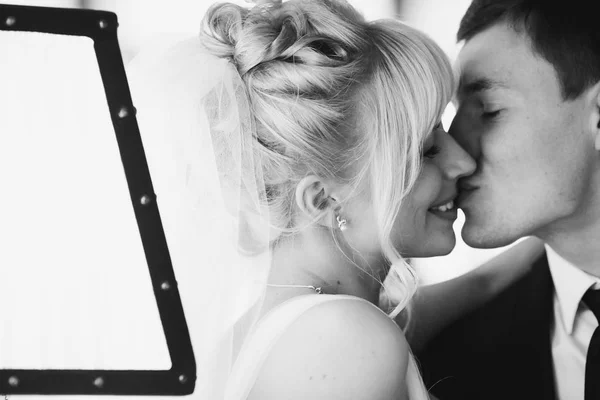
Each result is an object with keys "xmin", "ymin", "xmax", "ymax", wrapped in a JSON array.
[{"xmin": 269, "ymin": 227, "xmax": 386, "ymax": 304}]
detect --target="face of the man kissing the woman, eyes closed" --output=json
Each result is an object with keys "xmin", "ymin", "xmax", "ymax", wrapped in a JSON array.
[{"xmin": 450, "ymin": 23, "xmax": 595, "ymax": 247}]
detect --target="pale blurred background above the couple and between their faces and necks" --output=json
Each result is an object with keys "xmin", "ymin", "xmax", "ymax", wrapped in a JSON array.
[{"xmin": 0, "ymin": 0, "xmax": 504, "ymax": 284}]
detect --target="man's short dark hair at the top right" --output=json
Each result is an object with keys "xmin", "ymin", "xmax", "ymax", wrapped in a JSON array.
[{"xmin": 457, "ymin": 0, "xmax": 600, "ymax": 99}]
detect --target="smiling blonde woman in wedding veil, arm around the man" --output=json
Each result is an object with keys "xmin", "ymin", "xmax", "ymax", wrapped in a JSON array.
[{"xmin": 130, "ymin": 0, "xmax": 541, "ymax": 400}]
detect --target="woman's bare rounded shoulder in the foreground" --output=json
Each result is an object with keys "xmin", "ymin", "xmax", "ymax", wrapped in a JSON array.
[{"xmin": 249, "ymin": 297, "xmax": 409, "ymax": 400}]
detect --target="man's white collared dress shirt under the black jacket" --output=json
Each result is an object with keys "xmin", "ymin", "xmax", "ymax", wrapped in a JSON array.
[{"xmin": 546, "ymin": 245, "xmax": 600, "ymax": 400}]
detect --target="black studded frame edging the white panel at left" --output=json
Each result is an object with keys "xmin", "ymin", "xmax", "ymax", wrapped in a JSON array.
[{"xmin": 0, "ymin": 4, "xmax": 196, "ymax": 395}]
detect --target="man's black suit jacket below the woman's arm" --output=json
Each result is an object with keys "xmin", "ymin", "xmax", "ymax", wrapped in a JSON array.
[{"xmin": 416, "ymin": 255, "xmax": 556, "ymax": 400}]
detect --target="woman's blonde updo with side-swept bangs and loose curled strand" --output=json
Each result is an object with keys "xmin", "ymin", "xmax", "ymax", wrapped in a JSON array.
[{"xmin": 202, "ymin": 0, "xmax": 454, "ymax": 322}]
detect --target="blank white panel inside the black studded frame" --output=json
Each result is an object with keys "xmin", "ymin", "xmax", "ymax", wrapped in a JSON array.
[{"xmin": 0, "ymin": 32, "xmax": 170, "ymax": 369}]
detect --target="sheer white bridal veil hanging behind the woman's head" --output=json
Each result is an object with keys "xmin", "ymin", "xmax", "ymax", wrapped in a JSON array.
[{"xmin": 127, "ymin": 38, "xmax": 275, "ymax": 399}]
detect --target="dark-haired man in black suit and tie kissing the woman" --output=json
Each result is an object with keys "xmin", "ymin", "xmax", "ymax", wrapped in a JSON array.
[{"xmin": 418, "ymin": 0, "xmax": 600, "ymax": 400}]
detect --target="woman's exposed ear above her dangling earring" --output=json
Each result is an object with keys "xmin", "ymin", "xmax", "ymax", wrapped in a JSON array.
[{"xmin": 296, "ymin": 175, "xmax": 339, "ymax": 227}]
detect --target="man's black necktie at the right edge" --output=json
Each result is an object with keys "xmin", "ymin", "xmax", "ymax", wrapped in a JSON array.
[{"xmin": 583, "ymin": 289, "xmax": 600, "ymax": 400}]
